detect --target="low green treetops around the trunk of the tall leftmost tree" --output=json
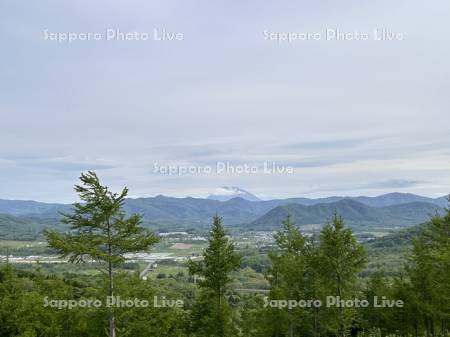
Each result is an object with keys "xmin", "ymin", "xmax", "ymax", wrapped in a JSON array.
[{"xmin": 0, "ymin": 267, "xmax": 187, "ymax": 337}]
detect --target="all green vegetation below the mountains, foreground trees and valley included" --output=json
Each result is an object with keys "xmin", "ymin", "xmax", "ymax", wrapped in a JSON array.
[{"xmin": 0, "ymin": 173, "xmax": 450, "ymax": 337}]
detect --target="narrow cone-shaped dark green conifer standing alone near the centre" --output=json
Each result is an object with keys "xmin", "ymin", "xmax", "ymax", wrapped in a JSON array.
[{"xmin": 189, "ymin": 215, "xmax": 241, "ymax": 337}]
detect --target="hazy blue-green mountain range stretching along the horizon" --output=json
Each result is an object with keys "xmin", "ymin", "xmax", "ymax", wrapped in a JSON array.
[{"xmin": 0, "ymin": 191, "xmax": 447, "ymax": 236}]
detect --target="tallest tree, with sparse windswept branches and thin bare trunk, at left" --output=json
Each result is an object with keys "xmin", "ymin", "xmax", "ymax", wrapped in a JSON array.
[{"xmin": 45, "ymin": 171, "xmax": 158, "ymax": 337}]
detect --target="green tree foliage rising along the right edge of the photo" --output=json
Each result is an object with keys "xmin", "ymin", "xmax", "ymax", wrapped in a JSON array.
[{"xmin": 361, "ymin": 202, "xmax": 450, "ymax": 336}]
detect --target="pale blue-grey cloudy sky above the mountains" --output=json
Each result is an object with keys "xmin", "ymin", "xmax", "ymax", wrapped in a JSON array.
[{"xmin": 0, "ymin": 0, "xmax": 450, "ymax": 202}]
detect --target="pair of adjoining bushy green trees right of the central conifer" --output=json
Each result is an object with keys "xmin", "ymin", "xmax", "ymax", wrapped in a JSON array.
[{"xmin": 251, "ymin": 215, "xmax": 366, "ymax": 337}]
